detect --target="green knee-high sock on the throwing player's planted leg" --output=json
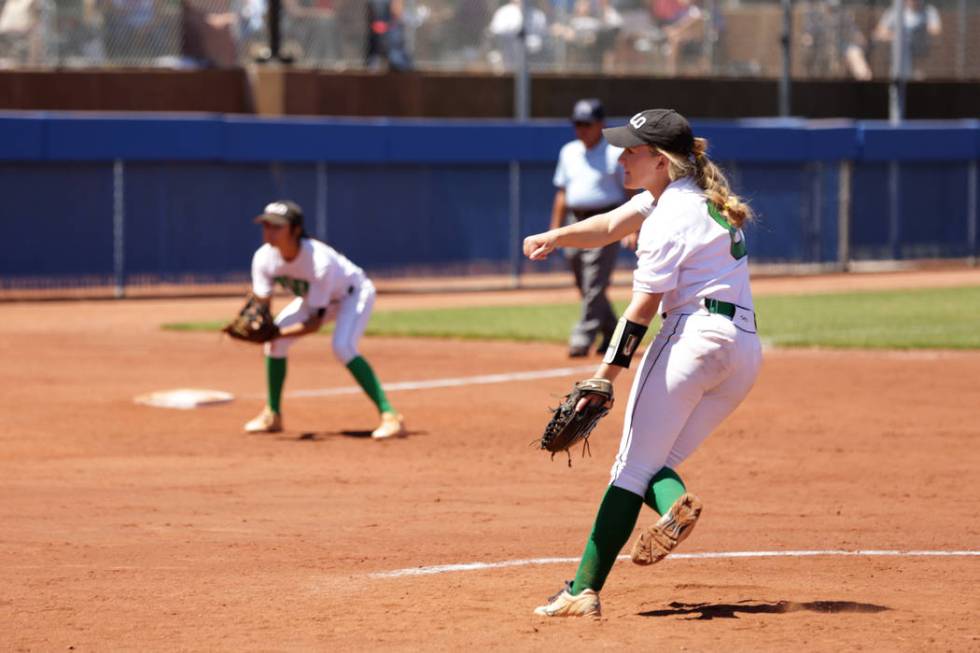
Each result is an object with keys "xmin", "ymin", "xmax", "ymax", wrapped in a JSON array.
[{"xmin": 572, "ymin": 485, "xmax": 643, "ymax": 594}]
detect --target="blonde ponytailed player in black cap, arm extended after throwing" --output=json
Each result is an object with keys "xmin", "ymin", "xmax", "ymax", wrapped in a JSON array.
[{"xmin": 524, "ymin": 109, "xmax": 762, "ymax": 617}]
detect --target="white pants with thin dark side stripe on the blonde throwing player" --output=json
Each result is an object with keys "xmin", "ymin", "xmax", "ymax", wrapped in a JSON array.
[{"xmin": 611, "ymin": 308, "xmax": 762, "ymax": 497}]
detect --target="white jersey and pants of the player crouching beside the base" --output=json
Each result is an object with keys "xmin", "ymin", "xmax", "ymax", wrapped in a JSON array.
[{"xmin": 252, "ymin": 238, "xmax": 376, "ymax": 365}]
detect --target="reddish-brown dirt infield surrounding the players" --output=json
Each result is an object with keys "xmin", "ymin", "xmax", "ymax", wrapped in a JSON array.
[{"xmin": 0, "ymin": 268, "xmax": 980, "ymax": 651}]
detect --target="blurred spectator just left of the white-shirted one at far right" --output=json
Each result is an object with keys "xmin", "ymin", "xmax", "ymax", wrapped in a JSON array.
[{"xmin": 800, "ymin": 0, "xmax": 871, "ymax": 80}]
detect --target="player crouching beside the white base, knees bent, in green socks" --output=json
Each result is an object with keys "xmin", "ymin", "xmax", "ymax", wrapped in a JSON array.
[{"xmin": 245, "ymin": 200, "xmax": 405, "ymax": 438}]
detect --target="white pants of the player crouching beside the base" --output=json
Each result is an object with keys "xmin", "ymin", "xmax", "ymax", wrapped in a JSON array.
[{"xmin": 265, "ymin": 279, "xmax": 375, "ymax": 365}]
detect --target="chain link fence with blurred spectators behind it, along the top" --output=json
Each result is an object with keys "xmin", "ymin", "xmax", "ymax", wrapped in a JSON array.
[{"xmin": 0, "ymin": 0, "xmax": 980, "ymax": 80}]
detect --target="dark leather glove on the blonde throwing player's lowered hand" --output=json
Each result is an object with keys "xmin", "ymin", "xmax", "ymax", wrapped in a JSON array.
[{"xmin": 540, "ymin": 378, "xmax": 613, "ymax": 466}]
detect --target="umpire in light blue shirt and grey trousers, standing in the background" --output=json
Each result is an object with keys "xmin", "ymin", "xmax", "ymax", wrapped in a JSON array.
[{"xmin": 549, "ymin": 98, "xmax": 626, "ymax": 358}]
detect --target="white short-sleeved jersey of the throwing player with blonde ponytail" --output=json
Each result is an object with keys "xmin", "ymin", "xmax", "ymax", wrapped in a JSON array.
[{"xmin": 627, "ymin": 177, "xmax": 754, "ymax": 313}]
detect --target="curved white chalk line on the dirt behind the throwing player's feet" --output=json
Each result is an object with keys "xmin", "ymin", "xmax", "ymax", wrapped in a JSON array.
[{"xmin": 368, "ymin": 549, "xmax": 980, "ymax": 578}]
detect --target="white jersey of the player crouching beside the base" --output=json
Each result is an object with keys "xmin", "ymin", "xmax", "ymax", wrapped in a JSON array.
[{"xmin": 252, "ymin": 238, "xmax": 364, "ymax": 308}]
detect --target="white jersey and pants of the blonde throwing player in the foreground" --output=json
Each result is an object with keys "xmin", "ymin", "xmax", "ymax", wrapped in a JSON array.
[{"xmin": 611, "ymin": 178, "xmax": 762, "ymax": 496}]
